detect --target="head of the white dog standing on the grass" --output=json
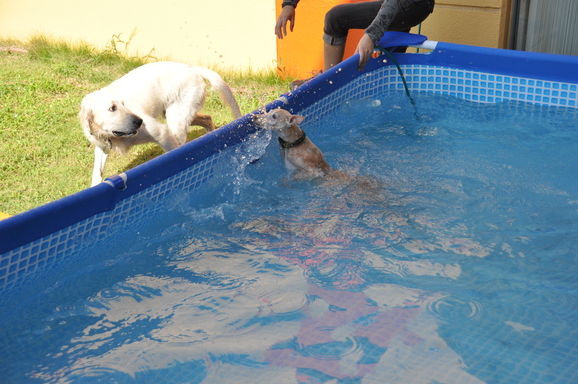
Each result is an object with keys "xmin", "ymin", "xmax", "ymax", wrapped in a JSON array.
[{"xmin": 78, "ymin": 90, "xmax": 142, "ymax": 152}]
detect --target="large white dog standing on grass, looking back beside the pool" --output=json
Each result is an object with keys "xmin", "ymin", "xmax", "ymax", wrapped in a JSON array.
[{"xmin": 79, "ymin": 61, "xmax": 241, "ymax": 186}]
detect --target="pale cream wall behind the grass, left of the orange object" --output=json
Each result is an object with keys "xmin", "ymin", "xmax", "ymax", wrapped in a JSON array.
[{"xmin": 0, "ymin": 0, "xmax": 276, "ymax": 69}]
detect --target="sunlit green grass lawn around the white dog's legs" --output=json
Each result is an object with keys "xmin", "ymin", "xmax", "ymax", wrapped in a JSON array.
[{"xmin": 0, "ymin": 36, "xmax": 288, "ymax": 215}]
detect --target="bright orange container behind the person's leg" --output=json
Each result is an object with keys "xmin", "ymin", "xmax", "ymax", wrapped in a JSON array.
[{"xmin": 275, "ymin": 0, "xmax": 363, "ymax": 79}]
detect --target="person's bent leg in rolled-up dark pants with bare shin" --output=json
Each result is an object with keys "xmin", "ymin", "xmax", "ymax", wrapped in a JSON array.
[{"xmin": 323, "ymin": 1, "xmax": 382, "ymax": 71}]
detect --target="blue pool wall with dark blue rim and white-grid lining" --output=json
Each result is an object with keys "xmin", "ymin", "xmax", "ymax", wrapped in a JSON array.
[{"xmin": 0, "ymin": 35, "xmax": 578, "ymax": 295}]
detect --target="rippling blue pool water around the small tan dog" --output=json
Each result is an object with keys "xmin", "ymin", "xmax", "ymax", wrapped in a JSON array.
[{"xmin": 0, "ymin": 92, "xmax": 578, "ymax": 384}]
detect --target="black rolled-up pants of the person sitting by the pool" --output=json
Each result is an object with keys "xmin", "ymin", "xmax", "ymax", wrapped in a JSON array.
[{"xmin": 323, "ymin": 1, "xmax": 433, "ymax": 45}]
